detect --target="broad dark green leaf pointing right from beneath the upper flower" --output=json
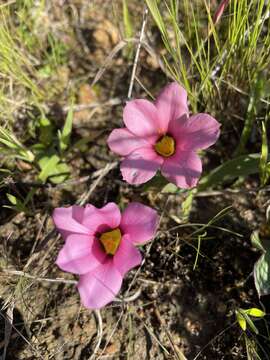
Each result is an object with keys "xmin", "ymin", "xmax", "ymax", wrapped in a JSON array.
[{"xmin": 199, "ymin": 154, "xmax": 260, "ymax": 190}]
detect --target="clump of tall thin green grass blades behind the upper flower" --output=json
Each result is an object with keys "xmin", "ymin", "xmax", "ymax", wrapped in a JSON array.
[{"xmin": 146, "ymin": 0, "xmax": 270, "ymax": 116}]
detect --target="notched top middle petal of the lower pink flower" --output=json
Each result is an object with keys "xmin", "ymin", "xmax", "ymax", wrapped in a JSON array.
[{"xmin": 82, "ymin": 203, "xmax": 121, "ymax": 234}]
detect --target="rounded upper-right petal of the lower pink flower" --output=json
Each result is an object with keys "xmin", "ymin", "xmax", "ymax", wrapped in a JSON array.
[{"xmin": 120, "ymin": 202, "xmax": 159, "ymax": 244}]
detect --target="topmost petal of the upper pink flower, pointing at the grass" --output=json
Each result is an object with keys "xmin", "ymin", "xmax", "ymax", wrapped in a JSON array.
[{"xmin": 155, "ymin": 82, "xmax": 188, "ymax": 132}]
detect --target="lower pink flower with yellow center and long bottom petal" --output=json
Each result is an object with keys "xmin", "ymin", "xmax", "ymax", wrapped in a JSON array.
[{"xmin": 53, "ymin": 202, "xmax": 158, "ymax": 309}]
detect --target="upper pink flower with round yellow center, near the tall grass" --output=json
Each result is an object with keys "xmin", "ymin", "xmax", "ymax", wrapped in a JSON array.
[{"xmin": 108, "ymin": 82, "xmax": 220, "ymax": 188}]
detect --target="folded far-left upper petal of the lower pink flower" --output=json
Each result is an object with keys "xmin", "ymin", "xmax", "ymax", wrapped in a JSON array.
[{"xmin": 52, "ymin": 205, "xmax": 90, "ymax": 239}]
